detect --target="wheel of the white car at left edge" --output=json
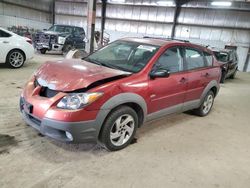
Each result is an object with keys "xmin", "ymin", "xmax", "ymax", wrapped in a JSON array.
[{"xmin": 6, "ymin": 50, "xmax": 25, "ymax": 69}]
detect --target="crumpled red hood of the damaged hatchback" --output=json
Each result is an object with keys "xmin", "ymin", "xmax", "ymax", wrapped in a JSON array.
[{"xmin": 35, "ymin": 59, "xmax": 131, "ymax": 92}]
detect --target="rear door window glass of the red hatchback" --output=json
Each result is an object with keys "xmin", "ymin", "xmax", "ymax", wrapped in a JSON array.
[{"xmin": 185, "ymin": 48, "xmax": 206, "ymax": 70}]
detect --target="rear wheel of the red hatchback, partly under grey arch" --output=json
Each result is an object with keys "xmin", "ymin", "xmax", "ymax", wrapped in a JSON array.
[{"xmin": 194, "ymin": 91, "xmax": 214, "ymax": 117}]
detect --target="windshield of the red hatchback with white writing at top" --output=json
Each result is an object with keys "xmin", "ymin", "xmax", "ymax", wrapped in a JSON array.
[{"xmin": 84, "ymin": 41, "xmax": 159, "ymax": 73}]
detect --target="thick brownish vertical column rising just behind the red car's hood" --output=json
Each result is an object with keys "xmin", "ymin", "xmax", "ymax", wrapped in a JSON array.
[{"xmin": 86, "ymin": 0, "xmax": 96, "ymax": 53}]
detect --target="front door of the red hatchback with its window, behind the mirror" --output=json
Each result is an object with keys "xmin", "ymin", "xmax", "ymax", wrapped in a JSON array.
[{"xmin": 149, "ymin": 47, "xmax": 187, "ymax": 114}]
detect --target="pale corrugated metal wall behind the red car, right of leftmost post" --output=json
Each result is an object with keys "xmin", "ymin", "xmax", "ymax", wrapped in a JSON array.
[{"xmin": 55, "ymin": 0, "xmax": 250, "ymax": 71}]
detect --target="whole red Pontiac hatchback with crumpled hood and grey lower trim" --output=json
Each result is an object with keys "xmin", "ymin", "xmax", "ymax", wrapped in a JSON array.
[{"xmin": 20, "ymin": 37, "xmax": 221, "ymax": 151}]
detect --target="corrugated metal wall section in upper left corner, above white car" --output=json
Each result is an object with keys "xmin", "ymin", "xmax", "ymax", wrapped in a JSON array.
[{"xmin": 0, "ymin": 0, "xmax": 52, "ymax": 29}]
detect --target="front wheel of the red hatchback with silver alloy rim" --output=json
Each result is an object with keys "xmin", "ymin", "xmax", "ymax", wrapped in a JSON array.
[{"xmin": 100, "ymin": 106, "xmax": 138, "ymax": 151}]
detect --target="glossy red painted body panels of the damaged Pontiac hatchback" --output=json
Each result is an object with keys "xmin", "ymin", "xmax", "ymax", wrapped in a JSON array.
[{"xmin": 22, "ymin": 38, "xmax": 221, "ymax": 144}]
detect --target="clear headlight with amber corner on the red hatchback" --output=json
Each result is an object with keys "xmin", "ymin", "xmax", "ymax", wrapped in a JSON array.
[{"xmin": 57, "ymin": 92, "xmax": 103, "ymax": 110}]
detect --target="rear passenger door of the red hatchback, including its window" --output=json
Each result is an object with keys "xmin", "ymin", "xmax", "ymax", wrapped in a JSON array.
[{"xmin": 184, "ymin": 47, "xmax": 213, "ymax": 106}]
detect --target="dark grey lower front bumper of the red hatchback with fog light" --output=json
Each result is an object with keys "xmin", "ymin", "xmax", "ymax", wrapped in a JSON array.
[{"xmin": 20, "ymin": 97, "xmax": 100, "ymax": 143}]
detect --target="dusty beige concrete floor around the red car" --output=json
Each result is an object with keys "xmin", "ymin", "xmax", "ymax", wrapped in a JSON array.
[{"xmin": 0, "ymin": 55, "xmax": 250, "ymax": 188}]
